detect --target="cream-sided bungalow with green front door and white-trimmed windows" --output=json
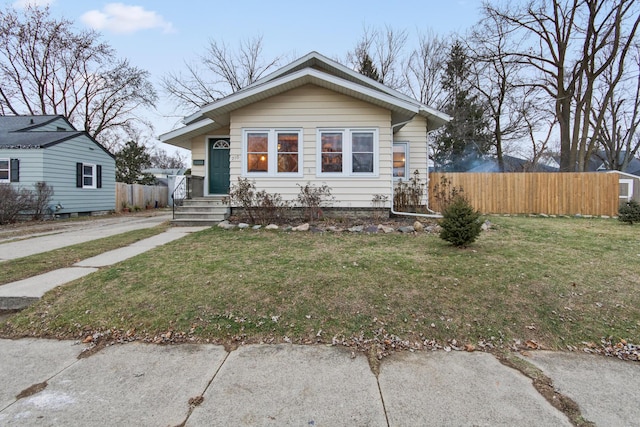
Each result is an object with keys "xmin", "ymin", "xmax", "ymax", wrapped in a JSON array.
[{"xmin": 160, "ymin": 52, "xmax": 449, "ymax": 224}]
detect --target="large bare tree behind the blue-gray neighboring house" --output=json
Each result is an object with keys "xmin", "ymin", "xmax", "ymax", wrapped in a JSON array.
[{"xmin": 0, "ymin": 6, "xmax": 157, "ymax": 149}]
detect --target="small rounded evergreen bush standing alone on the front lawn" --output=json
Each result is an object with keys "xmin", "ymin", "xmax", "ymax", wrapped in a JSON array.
[{"xmin": 440, "ymin": 195, "xmax": 482, "ymax": 247}]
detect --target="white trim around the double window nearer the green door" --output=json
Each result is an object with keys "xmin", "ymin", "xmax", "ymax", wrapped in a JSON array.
[{"xmin": 242, "ymin": 128, "xmax": 304, "ymax": 178}]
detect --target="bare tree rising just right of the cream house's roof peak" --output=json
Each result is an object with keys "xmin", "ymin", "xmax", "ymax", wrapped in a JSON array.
[{"xmin": 347, "ymin": 26, "xmax": 407, "ymax": 90}]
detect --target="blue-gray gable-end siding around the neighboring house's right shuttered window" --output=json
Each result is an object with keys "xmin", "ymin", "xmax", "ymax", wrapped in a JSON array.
[{"xmin": 43, "ymin": 135, "xmax": 116, "ymax": 213}]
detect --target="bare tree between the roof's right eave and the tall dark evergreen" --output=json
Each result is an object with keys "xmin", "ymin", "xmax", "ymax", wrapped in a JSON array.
[{"xmin": 402, "ymin": 31, "xmax": 449, "ymax": 108}]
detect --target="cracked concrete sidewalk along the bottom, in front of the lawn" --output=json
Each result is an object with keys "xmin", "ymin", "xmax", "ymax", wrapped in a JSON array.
[{"xmin": 0, "ymin": 339, "xmax": 640, "ymax": 426}]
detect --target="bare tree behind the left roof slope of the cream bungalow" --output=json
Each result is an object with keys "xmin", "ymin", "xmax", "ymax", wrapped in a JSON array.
[{"xmin": 162, "ymin": 36, "xmax": 283, "ymax": 111}]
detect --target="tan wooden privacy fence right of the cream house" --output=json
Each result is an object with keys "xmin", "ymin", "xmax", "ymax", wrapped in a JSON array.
[{"xmin": 429, "ymin": 172, "xmax": 619, "ymax": 216}]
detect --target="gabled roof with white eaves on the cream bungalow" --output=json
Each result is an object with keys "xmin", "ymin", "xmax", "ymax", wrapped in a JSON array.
[{"xmin": 160, "ymin": 52, "xmax": 450, "ymax": 143}]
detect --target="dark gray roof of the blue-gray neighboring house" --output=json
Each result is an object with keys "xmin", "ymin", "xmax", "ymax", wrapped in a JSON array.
[{"xmin": 0, "ymin": 115, "xmax": 114, "ymax": 157}]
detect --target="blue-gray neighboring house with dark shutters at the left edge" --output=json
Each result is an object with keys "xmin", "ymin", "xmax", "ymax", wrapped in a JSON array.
[{"xmin": 0, "ymin": 115, "xmax": 115, "ymax": 215}]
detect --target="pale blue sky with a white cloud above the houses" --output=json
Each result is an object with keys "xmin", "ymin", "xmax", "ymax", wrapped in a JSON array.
[{"xmin": 6, "ymin": 0, "xmax": 481, "ymax": 151}]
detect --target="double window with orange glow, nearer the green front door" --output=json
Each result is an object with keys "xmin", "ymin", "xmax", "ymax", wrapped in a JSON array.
[{"xmin": 243, "ymin": 129, "xmax": 302, "ymax": 177}]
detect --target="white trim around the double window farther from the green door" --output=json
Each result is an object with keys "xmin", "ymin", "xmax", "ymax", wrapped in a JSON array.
[{"xmin": 316, "ymin": 128, "xmax": 380, "ymax": 178}]
